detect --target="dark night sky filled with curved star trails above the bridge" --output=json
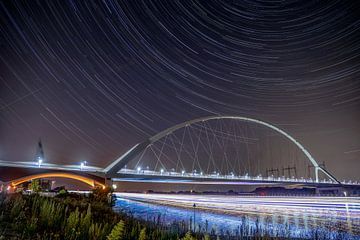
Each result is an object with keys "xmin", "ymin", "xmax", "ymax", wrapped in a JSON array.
[{"xmin": 0, "ymin": 0, "xmax": 360, "ymax": 180}]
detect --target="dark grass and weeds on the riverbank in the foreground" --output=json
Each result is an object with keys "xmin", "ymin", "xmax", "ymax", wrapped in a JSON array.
[{"xmin": 0, "ymin": 189, "xmax": 356, "ymax": 240}]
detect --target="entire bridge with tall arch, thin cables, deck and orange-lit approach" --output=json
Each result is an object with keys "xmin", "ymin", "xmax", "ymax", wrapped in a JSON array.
[{"xmin": 0, "ymin": 116, "xmax": 359, "ymax": 193}]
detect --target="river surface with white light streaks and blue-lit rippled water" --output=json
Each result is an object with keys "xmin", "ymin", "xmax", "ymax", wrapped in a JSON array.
[{"xmin": 114, "ymin": 193, "xmax": 360, "ymax": 239}]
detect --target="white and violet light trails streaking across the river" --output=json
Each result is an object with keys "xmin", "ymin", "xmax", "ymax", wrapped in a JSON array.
[{"xmin": 116, "ymin": 193, "xmax": 360, "ymax": 234}]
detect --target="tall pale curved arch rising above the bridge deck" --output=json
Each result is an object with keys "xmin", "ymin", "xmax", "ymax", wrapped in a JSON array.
[{"xmin": 104, "ymin": 116, "xmax": 340, "ymax": 183}]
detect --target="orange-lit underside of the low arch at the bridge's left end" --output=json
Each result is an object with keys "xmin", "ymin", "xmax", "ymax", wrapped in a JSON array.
[{"xmin": 11, "ymin": 172, "xmax": 105, "ymax": 187}]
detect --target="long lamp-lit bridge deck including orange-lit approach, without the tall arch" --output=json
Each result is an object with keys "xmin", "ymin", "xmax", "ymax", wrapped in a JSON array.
[{"xmin": 0, "ymin": 161, "xmax": 360, "ymax": 193}]
